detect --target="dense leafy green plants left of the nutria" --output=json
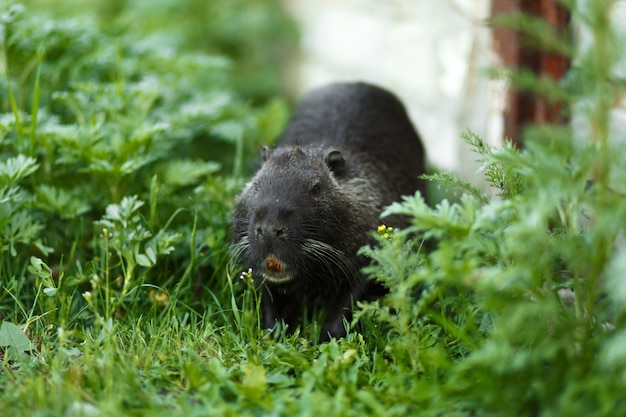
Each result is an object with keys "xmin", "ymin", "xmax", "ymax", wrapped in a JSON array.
[{"xmin": 0, "ymin": 1, "xmax": 285, "ymax": 332}]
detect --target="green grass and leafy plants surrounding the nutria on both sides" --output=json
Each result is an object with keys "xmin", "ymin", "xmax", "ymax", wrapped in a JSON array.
[{"xmin": 0, "ymin": 0, "xmax": 626, "ymax": 417}]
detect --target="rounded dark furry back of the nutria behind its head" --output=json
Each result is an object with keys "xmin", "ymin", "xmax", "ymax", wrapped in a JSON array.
[{"xmin": 277, "ymin": 82, "xmax": 426, "ymax": 205}]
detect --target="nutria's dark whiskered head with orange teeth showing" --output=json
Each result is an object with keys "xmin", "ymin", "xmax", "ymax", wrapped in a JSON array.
[{"xmin": 233, "ymin": 145, "xmax": 354, "ymax": 289}]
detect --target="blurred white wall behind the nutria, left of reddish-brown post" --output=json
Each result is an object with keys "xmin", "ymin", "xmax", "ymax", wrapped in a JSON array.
[{"xmin": 286, "ymin": 0, "xmax": 505, "ymax": 184}]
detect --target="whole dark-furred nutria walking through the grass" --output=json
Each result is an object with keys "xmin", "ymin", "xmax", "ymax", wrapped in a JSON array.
[{"xmin": 233, "ymin": 83, "xmax": 425, "ymax": 340}]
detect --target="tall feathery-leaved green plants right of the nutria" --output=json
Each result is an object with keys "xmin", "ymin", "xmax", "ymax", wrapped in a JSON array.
[{"xmin": 356, "ymin": 1, "xmax": 626, "ymax": 416}]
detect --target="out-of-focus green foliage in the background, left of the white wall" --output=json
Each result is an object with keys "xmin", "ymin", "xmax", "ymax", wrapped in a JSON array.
[{"xmin": 20, "ymin": 0, "xmax": 298, "ymax": 102}]
